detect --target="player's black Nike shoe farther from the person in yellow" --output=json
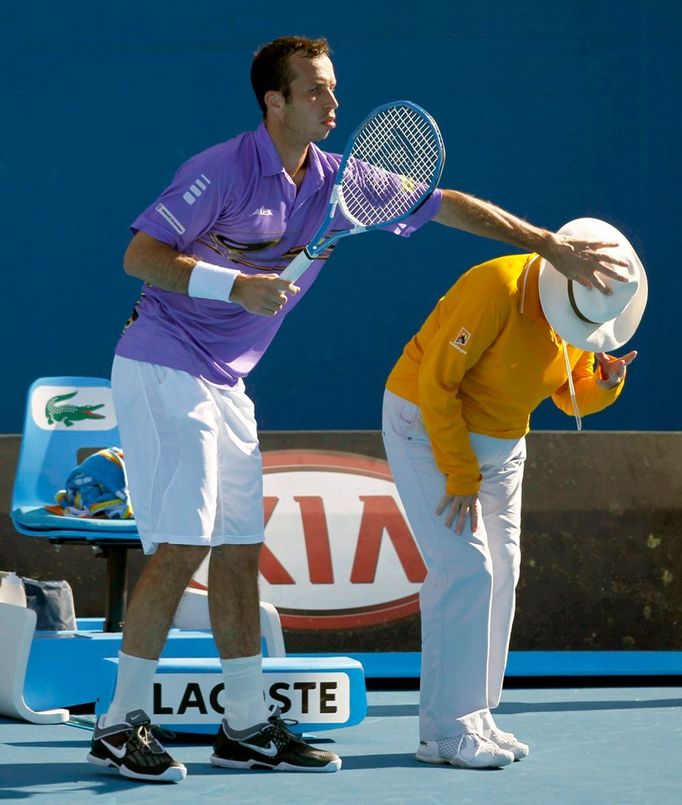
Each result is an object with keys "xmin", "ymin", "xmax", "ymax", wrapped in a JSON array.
[{"xmin": 88, "ymin": 710, "xmax": 187, "ymax": 783}]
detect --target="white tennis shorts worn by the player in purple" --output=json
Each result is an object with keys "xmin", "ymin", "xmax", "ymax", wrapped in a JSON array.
[{"xmin": 111, "ymin": 355, "xmax": 264, "ymax": 553}]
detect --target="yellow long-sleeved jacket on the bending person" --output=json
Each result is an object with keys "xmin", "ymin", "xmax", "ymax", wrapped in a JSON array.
[{"xmin": 386, "ymin": 254, "xmax": 623, "ymax": 495}]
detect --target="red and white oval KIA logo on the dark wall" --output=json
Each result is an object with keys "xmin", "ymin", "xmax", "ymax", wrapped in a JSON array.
[{"xmin": 260, "ymin": 450, "xmax": 426, "ymax": 630}]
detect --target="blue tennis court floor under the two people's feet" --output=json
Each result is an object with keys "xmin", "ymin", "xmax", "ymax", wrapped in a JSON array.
[{"xmin": 0, "ymin": 686, "xmax": 682, "ymax": 805}]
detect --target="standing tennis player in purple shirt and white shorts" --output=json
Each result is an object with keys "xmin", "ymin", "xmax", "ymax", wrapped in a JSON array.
[{"xmin": 89, "ymin": 37, "xmax": 632, "ymax": 781}]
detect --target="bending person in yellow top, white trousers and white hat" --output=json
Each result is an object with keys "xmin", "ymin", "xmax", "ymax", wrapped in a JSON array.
[{"xmin": 383, "ymin": 218, "xmax": 647, "ymax": 768}]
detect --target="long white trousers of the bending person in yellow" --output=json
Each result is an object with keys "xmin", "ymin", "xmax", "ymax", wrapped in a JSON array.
[{"xmin": 383, "ymin": 391, "xmax": 526, "ymax": 741}]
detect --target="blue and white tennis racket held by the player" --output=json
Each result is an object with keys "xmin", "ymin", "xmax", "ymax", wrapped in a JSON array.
[{"xmin": 281, "ymin": 101, "xmax": 445, "ymax": 282}]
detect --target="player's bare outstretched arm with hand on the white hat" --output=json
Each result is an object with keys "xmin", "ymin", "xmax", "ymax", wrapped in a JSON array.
[{"xmin": 434, "ymin": 190, "xmax": 625, "ymax": 293}]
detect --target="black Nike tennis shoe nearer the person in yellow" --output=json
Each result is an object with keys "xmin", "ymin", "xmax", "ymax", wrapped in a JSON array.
[{"xmin": 211, "ymin": 710, "xmax": 341, "ymax": 772}]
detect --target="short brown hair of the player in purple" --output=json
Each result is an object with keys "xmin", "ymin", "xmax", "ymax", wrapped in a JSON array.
[{"xmin": 251, "ymin": 36, "xmax": 330, "ymax": 115}]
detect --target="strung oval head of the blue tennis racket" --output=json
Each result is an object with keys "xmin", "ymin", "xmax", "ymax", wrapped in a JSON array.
[{"xmin": 339, "ymin": 105, "xmax": 443, "ymax": 226}]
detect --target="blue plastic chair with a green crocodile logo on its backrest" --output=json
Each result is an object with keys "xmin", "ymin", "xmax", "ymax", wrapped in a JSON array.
[{"xmin": 11, "ymin": 377, "xmax": 140, "ymax": 631}]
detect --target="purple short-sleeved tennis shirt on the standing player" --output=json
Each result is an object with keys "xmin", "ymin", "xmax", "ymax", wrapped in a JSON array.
[{"xmin": 116, "ymin": 123, "xmax": 441, "ymax": 386}]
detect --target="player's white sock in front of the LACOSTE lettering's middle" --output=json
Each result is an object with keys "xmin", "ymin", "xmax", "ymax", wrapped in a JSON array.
[{"xmin": 220, "ymin": 654, "xmax": 270, "ymax": 730}]
